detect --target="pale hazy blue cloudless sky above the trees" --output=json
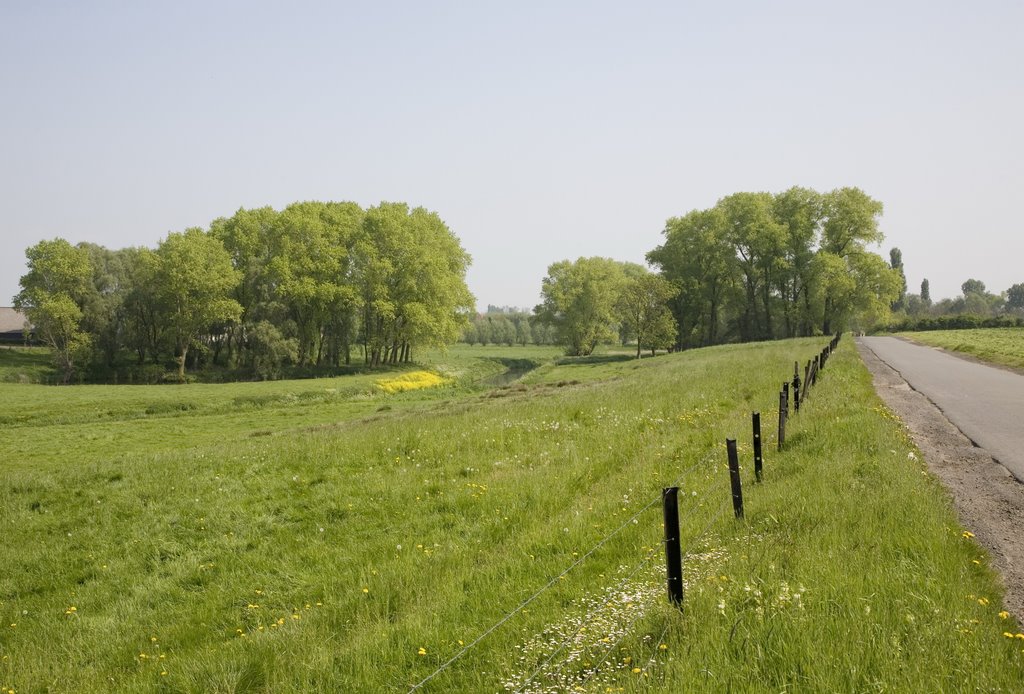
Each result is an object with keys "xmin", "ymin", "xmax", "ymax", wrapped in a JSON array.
[{"xmin": 0, "ymin": 0, "xmax": 1024, "ymax": 310}]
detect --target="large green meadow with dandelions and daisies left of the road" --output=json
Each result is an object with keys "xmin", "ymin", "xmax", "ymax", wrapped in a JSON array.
[{"xmin": 0, "ymin": 340, "xmax": 1024, "ymax": 694}]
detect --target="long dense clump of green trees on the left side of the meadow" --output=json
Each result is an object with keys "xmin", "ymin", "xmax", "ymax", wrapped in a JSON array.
[{"xmin": 14, "ymin": 202, "xmax": 474, "ymax": 380}]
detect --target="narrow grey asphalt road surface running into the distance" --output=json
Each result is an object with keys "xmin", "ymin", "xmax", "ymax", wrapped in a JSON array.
[{"xmin": 858, "ymin": 338, "xmax": 1024, "ymax": 482}]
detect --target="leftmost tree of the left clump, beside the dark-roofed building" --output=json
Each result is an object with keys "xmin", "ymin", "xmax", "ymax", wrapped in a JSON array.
[{"xmin": 14, "ymin": 238, "xmax": 92, "ymax": 383}]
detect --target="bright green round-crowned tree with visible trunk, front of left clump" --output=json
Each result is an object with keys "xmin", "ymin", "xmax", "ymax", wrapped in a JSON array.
[{"xmin": 154, "ymin": 227, "xmax": 242, "ymax": 382}]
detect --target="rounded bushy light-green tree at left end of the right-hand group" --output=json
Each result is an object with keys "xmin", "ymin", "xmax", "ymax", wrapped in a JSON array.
[{"xmin": 535, "ymin": 257, "xmax": 625, "ymax": 356}]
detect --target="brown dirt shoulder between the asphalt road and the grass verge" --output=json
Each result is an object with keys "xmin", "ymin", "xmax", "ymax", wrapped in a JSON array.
[{"xmin": 857, "ymin": 339, "xmax": 1024, "ymax": 621}]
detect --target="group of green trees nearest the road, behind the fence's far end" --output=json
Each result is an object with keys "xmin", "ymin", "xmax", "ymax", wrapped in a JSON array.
[{"xmin": 535, "ymin": 187, "xmax": 905, "ymax": 354}]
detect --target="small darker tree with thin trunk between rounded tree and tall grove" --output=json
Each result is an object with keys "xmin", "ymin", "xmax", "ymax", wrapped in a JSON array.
[{"xmin": 616, "ymin": 268, "xmax": 679, "ymax": 359}]
